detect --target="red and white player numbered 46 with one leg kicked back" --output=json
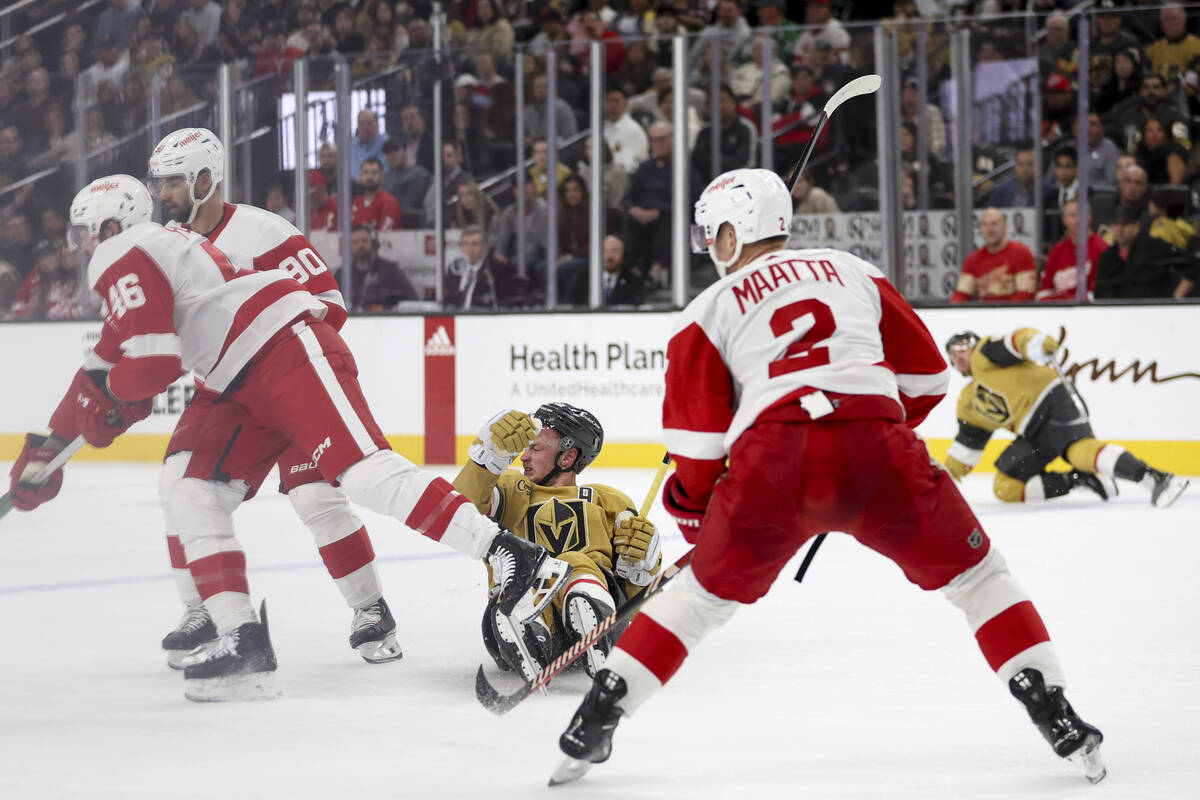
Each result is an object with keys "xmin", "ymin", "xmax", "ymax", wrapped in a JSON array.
[{"xmin": 12, "ymin": 175, "xmax": 570, "ymax": 700}]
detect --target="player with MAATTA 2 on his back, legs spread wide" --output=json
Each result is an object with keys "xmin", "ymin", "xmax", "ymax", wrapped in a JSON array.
[{"xmin": 551, "ymin": 169, "xmax": 1104, "ymax": 784}]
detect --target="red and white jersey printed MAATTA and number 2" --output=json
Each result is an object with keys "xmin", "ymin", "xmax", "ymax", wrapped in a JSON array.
[{"xmin": 662, "ymin": 249, "xmax": 949, "ymax": 501}]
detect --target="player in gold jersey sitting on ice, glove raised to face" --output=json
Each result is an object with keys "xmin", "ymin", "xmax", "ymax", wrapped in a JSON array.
[{"xmin": 454, "ymin": 403, "xmax": 661, "ymax": 680}]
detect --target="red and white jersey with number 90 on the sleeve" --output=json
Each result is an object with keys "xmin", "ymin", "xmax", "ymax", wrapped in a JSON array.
[{"xmin": 196, "ymin": 203, "xmax": 347, "ymax": 330}]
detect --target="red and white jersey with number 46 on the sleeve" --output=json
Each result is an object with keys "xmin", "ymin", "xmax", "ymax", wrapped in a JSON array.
[{"xmin": 73, "ymin": 222, "xmax": 328, "ymax": 402}]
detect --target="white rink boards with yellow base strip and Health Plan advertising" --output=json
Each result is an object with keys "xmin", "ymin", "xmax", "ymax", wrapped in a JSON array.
[{"xmin": 0, "ymin": 306, "xmax": 1200, "ymax": 475}]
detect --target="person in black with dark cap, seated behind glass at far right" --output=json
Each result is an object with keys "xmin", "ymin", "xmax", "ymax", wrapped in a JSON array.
[{"xmin": 1096, "ymin": 205, "xmax": 1200, "ymax": 300}]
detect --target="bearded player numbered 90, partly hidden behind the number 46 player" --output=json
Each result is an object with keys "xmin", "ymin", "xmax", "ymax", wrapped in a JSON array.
[{"xmin": 149, "ymin": 128, "xmax": 402, "ymax": 669}]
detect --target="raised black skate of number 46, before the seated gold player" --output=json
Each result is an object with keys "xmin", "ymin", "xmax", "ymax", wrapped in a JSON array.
[{"xmin": 487, "ymin": 531, "xmax": 571, "ymax": 622}]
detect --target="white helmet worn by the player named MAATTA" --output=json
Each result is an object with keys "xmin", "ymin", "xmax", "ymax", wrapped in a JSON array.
[{"xmin": 691, "ymin": 169, "xmax": 792, "ymax": 278}]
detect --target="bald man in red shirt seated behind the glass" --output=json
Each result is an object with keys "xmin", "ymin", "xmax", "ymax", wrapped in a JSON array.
[{"xmin": 950, "ymin": 209, "xmax": 1038, "ymax": 302}]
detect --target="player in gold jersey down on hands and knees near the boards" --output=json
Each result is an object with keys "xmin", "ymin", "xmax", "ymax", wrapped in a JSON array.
[{"xmin": 946, "ymin": 327, "xmax": 1188, "ymax": 506}]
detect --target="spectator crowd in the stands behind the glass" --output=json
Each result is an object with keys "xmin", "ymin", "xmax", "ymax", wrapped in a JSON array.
[{"xmin": 0, "ymin": 0, "xmax": 1200, "ymax": 319}]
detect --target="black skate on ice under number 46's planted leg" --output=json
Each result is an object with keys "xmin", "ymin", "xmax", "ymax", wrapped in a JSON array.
[{"xmin": 184, "ymin": 602, "xmax": 280, "ymax": 703}]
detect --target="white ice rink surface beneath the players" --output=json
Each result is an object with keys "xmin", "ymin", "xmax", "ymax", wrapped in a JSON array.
[{"xmin": 0, "ymin": 463, "xmax": 1200, "ymax": 800}]
